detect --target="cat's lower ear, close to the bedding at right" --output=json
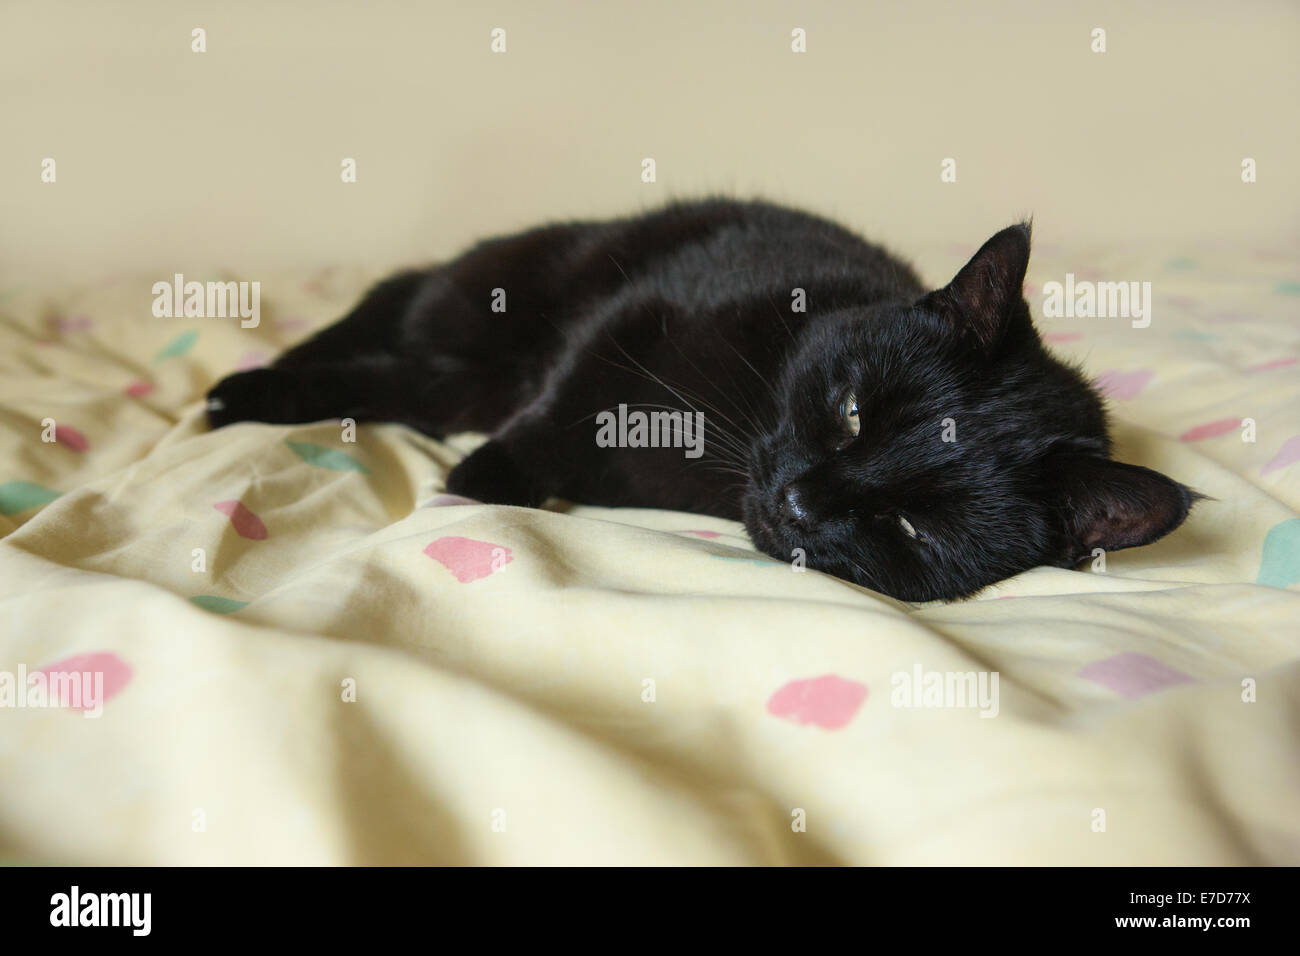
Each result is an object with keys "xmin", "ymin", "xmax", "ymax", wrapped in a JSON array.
[{"xmin": 1047, "ymin": 454, "xmax": 1204, "ymax": 561}]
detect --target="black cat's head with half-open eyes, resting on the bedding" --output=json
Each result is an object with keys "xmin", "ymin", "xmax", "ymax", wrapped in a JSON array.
[{"xmin": 744, "ymin": 225, "xmax": 1197, "ymax": 601}]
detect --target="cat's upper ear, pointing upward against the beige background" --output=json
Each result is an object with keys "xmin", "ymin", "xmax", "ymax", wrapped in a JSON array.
[{"xmin": 917, "ymin": 222, "xmax": 1030, "ymax": 350}]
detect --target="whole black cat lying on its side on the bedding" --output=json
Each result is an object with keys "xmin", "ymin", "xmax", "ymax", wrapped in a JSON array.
[{"xmin": 208, "ymin": 199, "xmax": 1199, "ymax": 601}]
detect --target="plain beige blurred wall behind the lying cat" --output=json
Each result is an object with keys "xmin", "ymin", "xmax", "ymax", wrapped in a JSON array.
[{"xmin": 0, "ymin": 0, "xmax": 1300, "ymax": 278}]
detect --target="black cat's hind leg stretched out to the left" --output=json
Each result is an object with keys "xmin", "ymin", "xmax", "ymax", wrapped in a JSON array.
[{"xmin": 208, "ymin": 226, "xmax": 600, "ymax": 437}]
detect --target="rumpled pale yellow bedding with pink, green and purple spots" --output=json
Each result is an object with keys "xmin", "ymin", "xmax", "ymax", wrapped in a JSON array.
[{"xmin": 0, "ymin": 242, "xmax": 1300, "ymax": 865}]
